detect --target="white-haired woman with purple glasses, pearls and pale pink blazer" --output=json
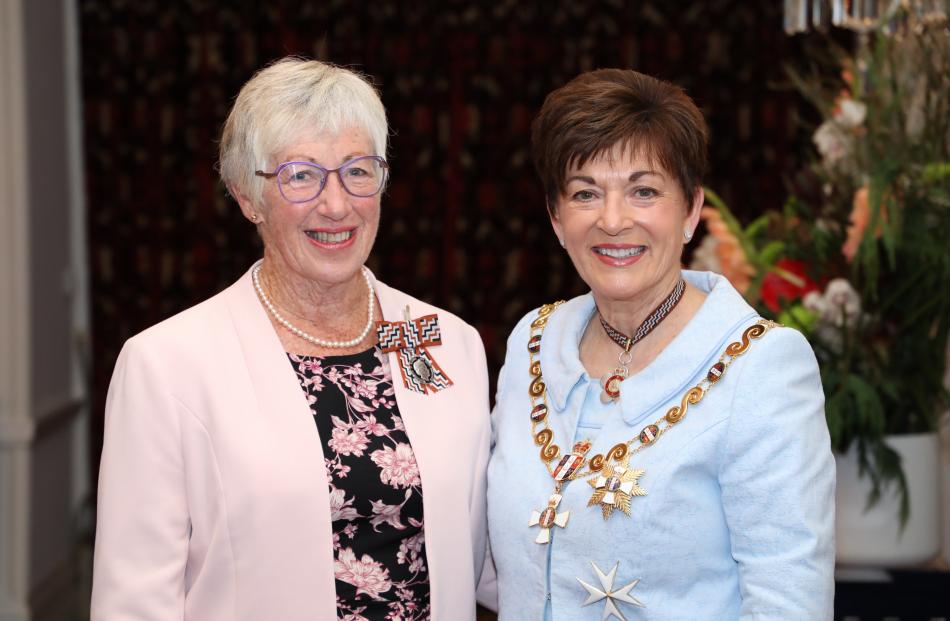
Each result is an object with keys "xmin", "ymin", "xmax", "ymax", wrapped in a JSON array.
[{"xmin": 92, "ymin": 58, "xmax": 490, "ymax": 621}]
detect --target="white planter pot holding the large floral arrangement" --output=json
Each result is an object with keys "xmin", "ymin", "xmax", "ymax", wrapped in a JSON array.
[{"xmin": 835, "ymin": 433, "xmax": 941, "ymax": 567}]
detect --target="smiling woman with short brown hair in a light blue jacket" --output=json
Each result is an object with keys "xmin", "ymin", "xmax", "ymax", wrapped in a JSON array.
[{"xmin": 488, "ymin": 69, "xmax": 835, "ymax": 621}]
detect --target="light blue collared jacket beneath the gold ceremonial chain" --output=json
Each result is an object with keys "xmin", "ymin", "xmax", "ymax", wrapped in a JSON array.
[{"xmin": 488, "ymin": 271, "xmax": 835, "ymax": 621}]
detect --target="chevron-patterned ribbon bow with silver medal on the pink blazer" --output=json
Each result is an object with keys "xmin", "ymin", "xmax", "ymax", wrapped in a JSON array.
[{"xmin": 376, "ymin": 315, "xmax": 452, "ymax": 394}]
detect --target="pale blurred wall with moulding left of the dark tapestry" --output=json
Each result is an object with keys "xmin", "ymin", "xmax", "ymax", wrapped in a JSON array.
[{"xmin": 0, "ymin": 0, "xmax": 89, "ymax": 621}]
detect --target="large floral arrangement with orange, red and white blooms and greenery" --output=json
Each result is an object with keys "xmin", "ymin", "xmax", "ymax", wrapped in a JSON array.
[{"xmin": 693, "ymin": 6, "xmax": 950, "ymax": 521}]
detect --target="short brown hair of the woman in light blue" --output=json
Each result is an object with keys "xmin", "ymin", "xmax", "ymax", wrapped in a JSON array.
[{"xmin": 531, "ymin": 69, "xmax": 709, "ymax": 215}]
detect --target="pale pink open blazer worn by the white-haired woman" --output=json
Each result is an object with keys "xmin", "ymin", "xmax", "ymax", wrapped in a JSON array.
[{"xmin": 92, "ymin": 272, "xmax": 490, "ymax": 621}]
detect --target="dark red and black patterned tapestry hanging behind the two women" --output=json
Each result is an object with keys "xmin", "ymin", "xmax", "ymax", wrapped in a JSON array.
[{"xmin": 80, "ymin": 0, "xmax": 820, "ymax": 461}]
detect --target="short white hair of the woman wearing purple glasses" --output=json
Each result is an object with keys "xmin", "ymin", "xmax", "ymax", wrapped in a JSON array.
[{"xmin": 218, "ymin": 56, "xmax": 388, "ymax": 203}]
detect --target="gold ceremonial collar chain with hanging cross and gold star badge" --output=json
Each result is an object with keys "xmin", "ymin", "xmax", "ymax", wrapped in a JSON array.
[{"xmin": 528, "ymin": 300, "xmax": 779, "ymax": 543}]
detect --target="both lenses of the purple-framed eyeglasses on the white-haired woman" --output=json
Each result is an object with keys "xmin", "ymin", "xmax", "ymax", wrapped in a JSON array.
[{"xmin": 277, "ymin": 156, "xmax": 386, "ymax": 202}]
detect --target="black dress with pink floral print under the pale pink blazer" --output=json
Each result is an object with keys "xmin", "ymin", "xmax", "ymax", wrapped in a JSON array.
[{"xmin": 288, "ymin": 347, "xmax": 430, "ymax": 621}]
